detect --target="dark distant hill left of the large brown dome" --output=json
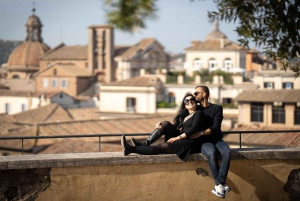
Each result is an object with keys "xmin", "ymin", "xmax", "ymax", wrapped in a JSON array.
[{"xmin": 0, "ymin": 39, "xmax": 23, "ymax": 66}]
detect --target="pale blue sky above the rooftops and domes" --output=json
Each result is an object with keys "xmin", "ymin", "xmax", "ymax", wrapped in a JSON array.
[{"xmin": 0, "ymin": 0, "xmax": 254, "ymax": 53}]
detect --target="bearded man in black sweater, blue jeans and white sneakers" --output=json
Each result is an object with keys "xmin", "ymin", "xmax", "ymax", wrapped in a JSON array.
[{"xmin": 191, "ymin": 86, "xmax": 231, "ymax": 198}]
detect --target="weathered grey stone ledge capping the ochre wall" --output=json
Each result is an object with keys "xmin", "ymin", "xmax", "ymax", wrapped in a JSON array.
[{"xmin": 0, "ymin": 147, "xmax": 300, "ymax": 170}]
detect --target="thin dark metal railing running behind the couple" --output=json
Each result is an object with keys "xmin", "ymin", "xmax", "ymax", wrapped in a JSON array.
[{"xmin": 0, "ymin": 130, "xmax": 300, "ymax": 155}]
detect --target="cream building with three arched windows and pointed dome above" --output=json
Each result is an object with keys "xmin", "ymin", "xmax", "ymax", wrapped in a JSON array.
[{"xmin": 185, "ymin": 23, "xmax": 248, "ymax": 75}]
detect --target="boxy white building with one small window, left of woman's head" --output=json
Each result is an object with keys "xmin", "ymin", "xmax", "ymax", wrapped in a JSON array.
[{"xmin": 99, "ymin": 75, "xmax": 163, "ymax": 114}]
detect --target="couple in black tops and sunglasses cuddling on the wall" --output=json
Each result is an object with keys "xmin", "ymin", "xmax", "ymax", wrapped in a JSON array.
[{"xmin": 121, "ymin": 86, "xmax": 231, "ymax": 198}]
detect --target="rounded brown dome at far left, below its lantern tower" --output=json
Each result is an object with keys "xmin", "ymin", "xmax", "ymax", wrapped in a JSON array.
[{"xmin": 7, "ymin": 41, "xmax": 50, "ymax": 67}]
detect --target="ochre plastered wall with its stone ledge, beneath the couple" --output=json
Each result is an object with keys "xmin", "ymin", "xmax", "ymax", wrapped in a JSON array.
[{"xmin": 0, "ymin": 148, "xmax": 300, "ymax": 201}]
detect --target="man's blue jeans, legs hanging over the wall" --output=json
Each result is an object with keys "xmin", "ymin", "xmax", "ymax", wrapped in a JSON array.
[{"xmin": 201, "ymin": 140, "xmax": 231, "ymax": 185}]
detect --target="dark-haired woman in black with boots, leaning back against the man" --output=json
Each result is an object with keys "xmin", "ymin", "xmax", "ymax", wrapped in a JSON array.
[{"xmin": 121, "ymin": 94, "xmax": 204, "ymax": 161}]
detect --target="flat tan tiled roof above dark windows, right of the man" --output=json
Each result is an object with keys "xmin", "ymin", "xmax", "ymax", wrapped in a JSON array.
[{"xmin": 235, "ymin": 89, "xmax": 300, "ymax": 103}]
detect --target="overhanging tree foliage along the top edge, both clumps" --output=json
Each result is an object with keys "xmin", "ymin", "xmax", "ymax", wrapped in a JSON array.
[{"xmin": 106, "ymin": 0, "xmax": 300, "ymax": 77}]
